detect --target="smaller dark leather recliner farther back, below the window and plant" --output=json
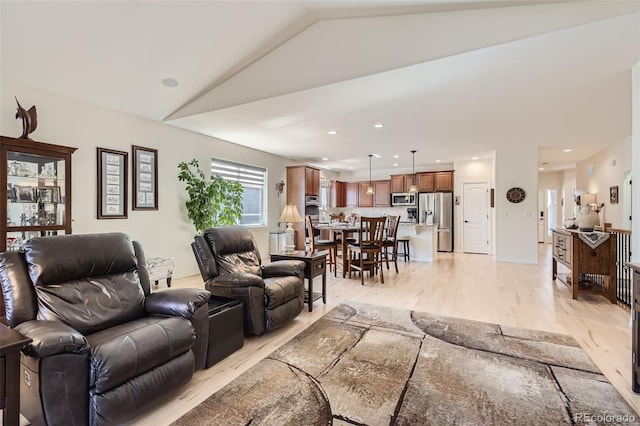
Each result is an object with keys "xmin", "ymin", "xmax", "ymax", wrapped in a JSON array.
[{"xmin": 191, "ymin": 226, "xmax": 304, "ymax": 336}]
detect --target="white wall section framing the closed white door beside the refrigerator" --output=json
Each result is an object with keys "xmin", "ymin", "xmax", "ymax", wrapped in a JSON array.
[{"xmin": 453, "ymin": 159, "xmax": 495, "ymax": 254}]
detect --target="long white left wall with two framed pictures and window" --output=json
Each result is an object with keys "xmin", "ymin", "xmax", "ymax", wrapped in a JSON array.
[{"xmin": 0, "ymin": 80, "xmax": 288, "ymax": 277}]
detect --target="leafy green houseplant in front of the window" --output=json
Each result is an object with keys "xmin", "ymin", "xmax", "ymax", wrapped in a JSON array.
[{"xmin": 178, "ymin": 159, "xmax": 243, "ymax": 234}]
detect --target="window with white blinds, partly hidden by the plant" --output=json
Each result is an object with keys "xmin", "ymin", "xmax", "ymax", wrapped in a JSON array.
[{"xmin": 211, "ymin": 158, "xmax": 267, "ymax": 225}]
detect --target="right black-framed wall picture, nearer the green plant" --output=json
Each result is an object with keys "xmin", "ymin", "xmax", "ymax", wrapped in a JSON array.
[{"xmin": 132, "ymin": 145, "xmax": 158, "ymax": 210}]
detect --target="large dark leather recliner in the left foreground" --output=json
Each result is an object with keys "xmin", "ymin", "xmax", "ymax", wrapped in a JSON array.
[{"xmin": 0, "ymin": 233, "xmax": 209, "ymax": 425}]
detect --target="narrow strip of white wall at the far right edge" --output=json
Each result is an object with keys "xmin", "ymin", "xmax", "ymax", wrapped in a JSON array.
[{"xmin": 631, "ymin": 62, "xmax": 640, "ymax": 262}]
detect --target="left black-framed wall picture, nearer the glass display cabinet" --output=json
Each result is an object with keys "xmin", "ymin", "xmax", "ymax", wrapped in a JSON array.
[{"xmin": 98, "ymin": 148, "xmax": 128, "ymax": 219}]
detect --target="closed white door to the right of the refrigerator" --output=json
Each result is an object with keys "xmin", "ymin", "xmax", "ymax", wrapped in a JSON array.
[{"xmin": 462, "ymin": 182, "xmax": 489, "ymax": 254}]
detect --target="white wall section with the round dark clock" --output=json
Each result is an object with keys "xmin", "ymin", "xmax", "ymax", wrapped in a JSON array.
[{"xmin": 494, "ymin": 143, "xmax": 538, "ymax": 264}]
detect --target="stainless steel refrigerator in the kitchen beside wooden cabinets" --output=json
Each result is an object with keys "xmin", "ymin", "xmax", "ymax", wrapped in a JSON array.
[{"xmin": 418, "ymin": 192, "xmax": 453, "ymax": 251}]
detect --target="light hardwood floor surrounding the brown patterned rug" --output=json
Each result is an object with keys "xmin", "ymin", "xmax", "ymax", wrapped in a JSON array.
[{"xmin": 134, "ymin": 244, "xmax": 640, "ymax": 426}]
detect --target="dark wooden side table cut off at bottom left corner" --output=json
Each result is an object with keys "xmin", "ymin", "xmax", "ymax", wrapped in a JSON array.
[{"xmin": 0, "ymin": 324, "xmax": 31, "ymax": 426}]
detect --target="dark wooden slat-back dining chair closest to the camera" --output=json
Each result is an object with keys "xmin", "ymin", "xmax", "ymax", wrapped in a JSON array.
[{"xmin": 348, "ymin": 216, "xmax": 387, "ymax": 285}]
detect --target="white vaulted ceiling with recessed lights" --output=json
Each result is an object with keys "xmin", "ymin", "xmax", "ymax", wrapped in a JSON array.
[{"xmin": 0, "ymin": 0, "xmax": 640, "ymax": 170}]
